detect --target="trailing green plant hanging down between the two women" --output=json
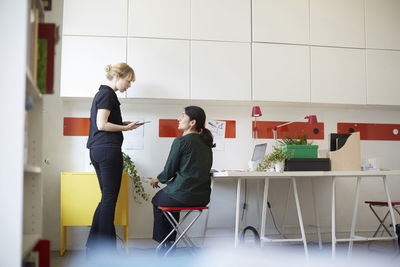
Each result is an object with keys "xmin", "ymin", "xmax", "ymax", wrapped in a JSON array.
[{"xmin": 122, "ymin": 152, "xmax": 150, "ymax": 204}]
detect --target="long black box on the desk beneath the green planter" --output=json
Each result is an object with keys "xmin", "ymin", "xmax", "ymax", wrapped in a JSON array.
[{"xmin": 285, "ymin": 158, "xmax": 331, "ymax": 171}]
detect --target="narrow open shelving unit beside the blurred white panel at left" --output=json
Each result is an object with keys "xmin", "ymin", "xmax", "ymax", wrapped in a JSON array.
[{"xmin": 22, "ymin": 0, "xmax": 44, "ymax": 264}]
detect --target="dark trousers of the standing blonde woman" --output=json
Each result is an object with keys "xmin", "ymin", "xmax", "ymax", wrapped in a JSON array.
[{"xmin": 86, "ymin": 147, "xmax": 123, "ymax": 249}]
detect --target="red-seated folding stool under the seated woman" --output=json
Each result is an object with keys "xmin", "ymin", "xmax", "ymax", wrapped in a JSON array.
[{"xmin": 156, "ymin": 206, "xmax": 208, "ymax": 256}]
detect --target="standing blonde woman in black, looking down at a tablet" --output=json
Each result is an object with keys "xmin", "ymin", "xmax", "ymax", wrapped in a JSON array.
[{"xmin": 86, "ymin": 63, "xmax": 139, "ymax": 253}]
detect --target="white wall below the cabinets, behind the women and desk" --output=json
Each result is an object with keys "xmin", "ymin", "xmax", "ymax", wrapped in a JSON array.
[{"xmin": 39, "ymin": 1, "xmax": 400, "ymax": 250}]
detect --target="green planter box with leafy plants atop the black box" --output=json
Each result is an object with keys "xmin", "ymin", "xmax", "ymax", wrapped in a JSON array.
[{"xmin": 279, "ymin": 135, "xmax": 318, "ymax": 158}]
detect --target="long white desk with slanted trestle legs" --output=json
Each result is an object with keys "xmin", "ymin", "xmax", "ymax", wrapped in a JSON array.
[{"xmin": 213, "ymin": 170, "xmax": 400, "ymax": 258}]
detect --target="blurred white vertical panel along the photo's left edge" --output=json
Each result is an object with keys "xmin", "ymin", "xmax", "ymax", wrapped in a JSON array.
[{"xmin": 0, "ymin": 1, "xmax": 28, "ymax": 266}]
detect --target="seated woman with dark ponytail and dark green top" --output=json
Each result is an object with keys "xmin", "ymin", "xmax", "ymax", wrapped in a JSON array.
[{"xmin": 150, "ymin": 106, "xmax": 215, "ymax": 250}]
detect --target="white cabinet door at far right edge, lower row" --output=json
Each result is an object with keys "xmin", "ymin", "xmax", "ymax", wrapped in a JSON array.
[{"xmin": 367, "ymin": 50, "xmax": 400, "ymax": 105}]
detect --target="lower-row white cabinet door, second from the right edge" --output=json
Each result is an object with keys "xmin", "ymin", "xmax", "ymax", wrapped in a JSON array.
[{"xmin": 311, "ymin": 47, "xmax": 366, "ymax": 104}]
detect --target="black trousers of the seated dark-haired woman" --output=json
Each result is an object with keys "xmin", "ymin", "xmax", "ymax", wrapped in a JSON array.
[{"xmin": 151, "ymin": 190, "xmax": 190, "ymax": 243}]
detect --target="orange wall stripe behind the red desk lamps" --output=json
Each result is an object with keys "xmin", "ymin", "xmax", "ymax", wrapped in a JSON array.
[{"xmin": 253, "ymin": 121, "xmax": 324, "ymax": 140}]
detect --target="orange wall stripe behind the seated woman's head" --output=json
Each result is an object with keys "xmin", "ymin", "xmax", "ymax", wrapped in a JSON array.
[{"xmin": 158, "ymin": 119, "xmax": 236, "ymax": 138}]
